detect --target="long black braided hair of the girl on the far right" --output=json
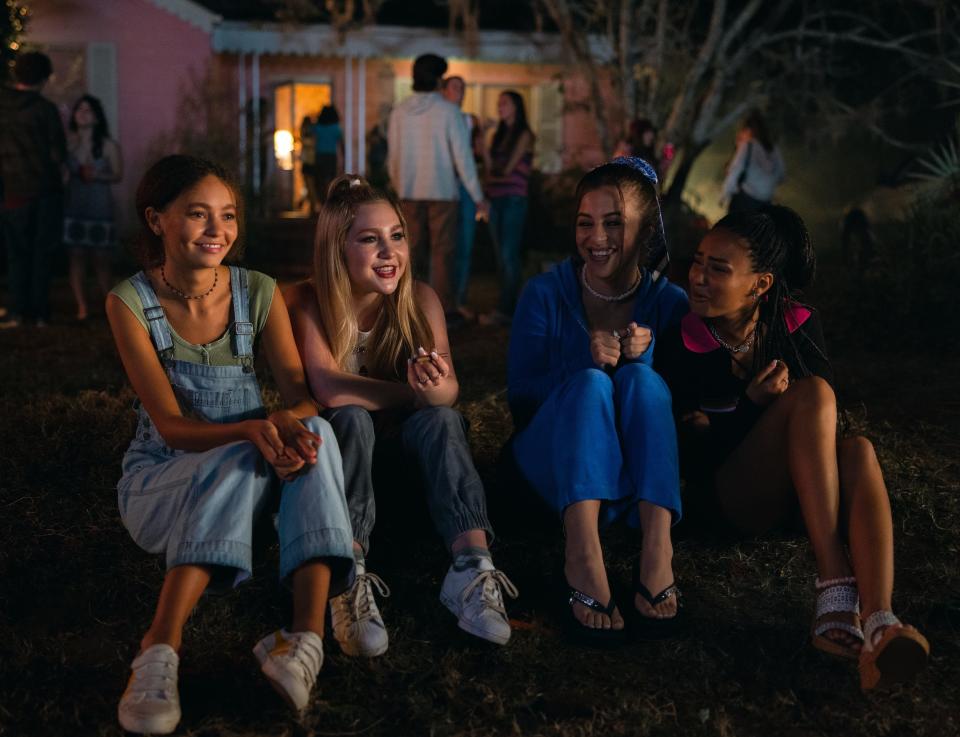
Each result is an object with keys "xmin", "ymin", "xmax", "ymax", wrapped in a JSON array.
[{"xmin": 714, "ymin": 205, "xmax": 827, "ymax": 378}]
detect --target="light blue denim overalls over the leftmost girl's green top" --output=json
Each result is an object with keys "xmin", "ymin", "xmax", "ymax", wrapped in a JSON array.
[{"xmin": 117, "ymin": 266, "xmax": 354, "ymax": 595}]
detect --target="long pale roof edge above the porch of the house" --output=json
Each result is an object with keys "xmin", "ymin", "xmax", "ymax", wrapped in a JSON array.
[{"xmin": 213, "ymin": 21, "xmax": 610, "ymax": 64}]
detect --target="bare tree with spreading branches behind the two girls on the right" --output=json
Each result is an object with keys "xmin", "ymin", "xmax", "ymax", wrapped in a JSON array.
[{"xmin": 536, "ymin": 0, "xmax": 956, "ymax": 204}]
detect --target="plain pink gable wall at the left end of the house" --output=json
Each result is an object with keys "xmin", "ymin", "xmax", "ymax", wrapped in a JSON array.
[{"xmin": 26, "ymin": 0, "xmax": 213, "ymax": 225}]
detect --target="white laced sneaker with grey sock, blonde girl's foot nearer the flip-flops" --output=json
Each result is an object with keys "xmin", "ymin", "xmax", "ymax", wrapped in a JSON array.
[{"xmin": 440, "ymin": 556, "xmax": 518, "ymax": 645}]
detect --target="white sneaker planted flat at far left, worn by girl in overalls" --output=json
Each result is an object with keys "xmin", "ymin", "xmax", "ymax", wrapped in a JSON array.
[{"xmin": 117, "ymin": 644, "xmax": 180, "ymax": 734}]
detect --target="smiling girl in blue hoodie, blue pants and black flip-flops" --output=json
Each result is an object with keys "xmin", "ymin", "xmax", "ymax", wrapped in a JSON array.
[{"xmin": 508, "ymin": 158, "xmax": 688, "ymax": 645}]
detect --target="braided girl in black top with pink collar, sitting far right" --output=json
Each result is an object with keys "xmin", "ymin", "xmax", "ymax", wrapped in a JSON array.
[{"xmin": 656, "ymin": 206, "xmax": 929, "ymax": 689}]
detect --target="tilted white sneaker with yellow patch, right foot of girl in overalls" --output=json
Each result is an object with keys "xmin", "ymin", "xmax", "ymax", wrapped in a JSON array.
[{"xmin": 253, "ymin": 630, "xmax": 323, "ymax": 711}]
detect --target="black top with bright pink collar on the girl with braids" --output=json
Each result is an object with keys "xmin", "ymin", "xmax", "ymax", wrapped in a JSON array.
[{"xmin": 655, "ymin": 302, "xmax": 833, "ymax": 464}]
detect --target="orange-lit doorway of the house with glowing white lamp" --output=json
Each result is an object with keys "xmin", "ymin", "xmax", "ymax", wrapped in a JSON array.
[{"xmin": 273, "ymin": 81, "xmax": 333, "ymax": 213}]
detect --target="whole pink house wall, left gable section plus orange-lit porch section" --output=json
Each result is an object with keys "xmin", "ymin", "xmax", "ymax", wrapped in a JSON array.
[{"xmin": 27, "ymin": 0, "xmax": 602, "ymax": 221}]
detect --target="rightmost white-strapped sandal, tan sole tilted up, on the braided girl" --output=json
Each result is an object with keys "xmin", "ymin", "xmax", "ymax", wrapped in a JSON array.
[{"xmin": 860, "ymin": 609, "xmax": 930, "ymax": 691}]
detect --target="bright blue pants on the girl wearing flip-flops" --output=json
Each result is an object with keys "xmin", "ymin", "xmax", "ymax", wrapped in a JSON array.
[{"xmin": 513, "ymin": 363, "xmax": 681, "ymax": 527}]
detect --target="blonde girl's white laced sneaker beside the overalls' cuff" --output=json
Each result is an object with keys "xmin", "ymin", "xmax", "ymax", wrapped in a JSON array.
[{"xmin": 330, "ymin": 560, "xmax": 390, "ymax": 658}]
